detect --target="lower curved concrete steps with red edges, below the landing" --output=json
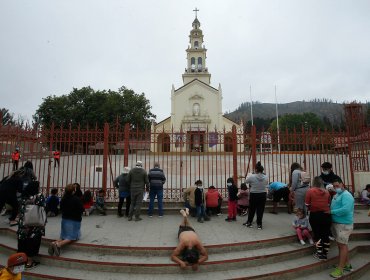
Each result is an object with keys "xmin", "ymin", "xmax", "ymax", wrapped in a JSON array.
[{"xmin": 0, "ymin": 241, "xmax": 370, "ymax": 279}]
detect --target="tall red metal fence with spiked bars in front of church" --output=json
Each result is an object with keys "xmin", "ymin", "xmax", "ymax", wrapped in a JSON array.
[{"xmin": 0, "ymin": 121, "xmax": 370, "ymax": 201}]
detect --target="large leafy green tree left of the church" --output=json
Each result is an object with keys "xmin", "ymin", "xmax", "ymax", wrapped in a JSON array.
[{"xmin": 33, "ymin": 86, "xmax": 156, "ymax": 129}]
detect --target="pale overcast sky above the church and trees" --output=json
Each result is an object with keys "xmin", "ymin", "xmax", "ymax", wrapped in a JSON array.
[{"xmin": 0, "ymin": 0, "xmax": 370, "ymax": 121}]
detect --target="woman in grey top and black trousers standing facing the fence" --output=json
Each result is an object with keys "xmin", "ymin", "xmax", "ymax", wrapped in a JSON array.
[{"xmin": 243, "ymin": 162, "xmax": 268, "ymax": 229}]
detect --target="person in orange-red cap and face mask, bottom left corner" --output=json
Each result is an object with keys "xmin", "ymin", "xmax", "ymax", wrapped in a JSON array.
[{"xmin": 0, "ymin": 253, "xmax": 27, "ymax": 280}]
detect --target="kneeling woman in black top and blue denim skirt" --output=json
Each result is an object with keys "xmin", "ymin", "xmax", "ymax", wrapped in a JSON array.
[{"xmin": 48, "ymin": 184, "xmax": 85, "ymax": 257}]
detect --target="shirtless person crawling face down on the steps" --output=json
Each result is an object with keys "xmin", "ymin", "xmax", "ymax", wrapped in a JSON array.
[{"xmin": 171, "ymin": 208, "xmax": 208, "ymax": 271}]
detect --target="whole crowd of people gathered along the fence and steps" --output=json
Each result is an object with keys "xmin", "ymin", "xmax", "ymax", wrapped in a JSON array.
[{"xmin": 0, "ymin": 161, "xmax": 364, "ymax": 277}]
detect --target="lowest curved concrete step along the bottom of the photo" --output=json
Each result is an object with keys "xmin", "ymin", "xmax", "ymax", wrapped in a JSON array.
[{"xmin": 0, "ymin": 242, "xmax": 370, "ymax": 280}]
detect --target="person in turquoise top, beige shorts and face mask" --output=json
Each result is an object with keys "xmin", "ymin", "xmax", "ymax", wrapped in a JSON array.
[{"xmin": 328, "ymin": 179, "xmax": 355, "ymax": 278}]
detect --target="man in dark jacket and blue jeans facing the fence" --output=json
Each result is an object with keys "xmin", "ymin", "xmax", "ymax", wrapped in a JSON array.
[{"xmin": 148, "ymin": 162, "xmax": 166, "ymax": 217}]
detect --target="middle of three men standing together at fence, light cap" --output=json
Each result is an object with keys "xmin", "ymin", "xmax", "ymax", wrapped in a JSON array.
[{"xmin": 127, "ymin": 161, "xmax": 149, "ymax": 222}]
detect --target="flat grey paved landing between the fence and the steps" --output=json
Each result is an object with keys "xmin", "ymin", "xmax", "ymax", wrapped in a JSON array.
[{"xmin": 10, "ymin": 210, "xmax": 370, "ymax": 247}]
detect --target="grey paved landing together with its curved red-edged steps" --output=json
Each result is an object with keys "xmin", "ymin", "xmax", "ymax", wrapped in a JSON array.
[{"xmin": 0, "ymin": 210, "xmax": 370, "ymax": 280}]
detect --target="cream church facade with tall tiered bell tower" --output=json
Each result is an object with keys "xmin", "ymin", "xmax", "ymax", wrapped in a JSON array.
[{"xmin": 151, "ymin": 14, "xmax": 243, "ymax": 152}]
